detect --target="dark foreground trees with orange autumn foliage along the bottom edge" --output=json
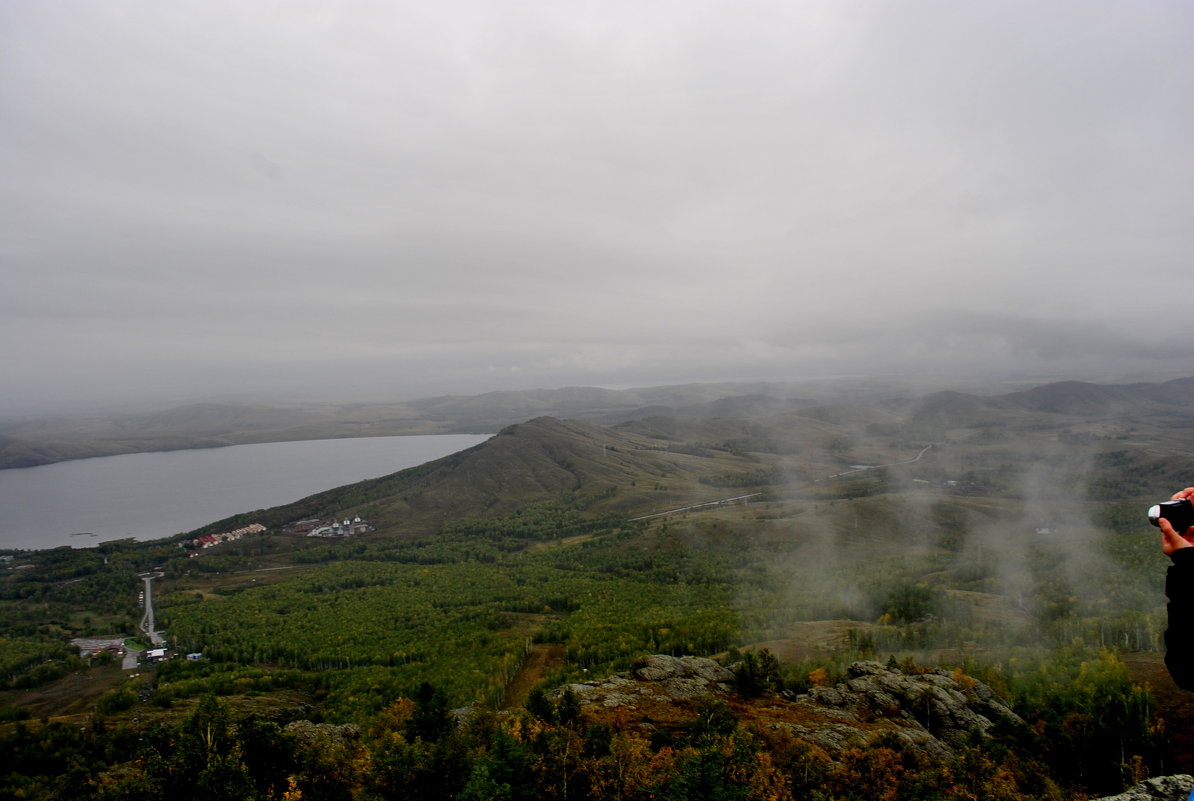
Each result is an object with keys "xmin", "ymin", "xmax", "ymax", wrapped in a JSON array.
[{"xmin": 0, "ymin": 653, "xmax": 1164, "ymax": 801}]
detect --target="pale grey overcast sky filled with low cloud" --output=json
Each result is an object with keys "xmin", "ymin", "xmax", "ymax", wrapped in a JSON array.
[{"xmin": 0, "ymin": 0, "xmax": 1194, "ymax": 413}]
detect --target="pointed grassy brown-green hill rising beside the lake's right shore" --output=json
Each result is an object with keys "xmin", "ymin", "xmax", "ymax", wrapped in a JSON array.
[{"xmin": 193, "ymin": 417, "xmax": 759, "ymax": 536}]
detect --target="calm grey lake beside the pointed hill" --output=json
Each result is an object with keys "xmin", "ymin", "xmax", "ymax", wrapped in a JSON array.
[{"xmin": 0, "ymin": 435, "xmax": 490, "ymax": 548}]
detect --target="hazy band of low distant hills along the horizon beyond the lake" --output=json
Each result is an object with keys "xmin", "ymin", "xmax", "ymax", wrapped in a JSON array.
[{"xmin": 0, "ymin": 378, "xmax": 1194, "ymax": 468}]
